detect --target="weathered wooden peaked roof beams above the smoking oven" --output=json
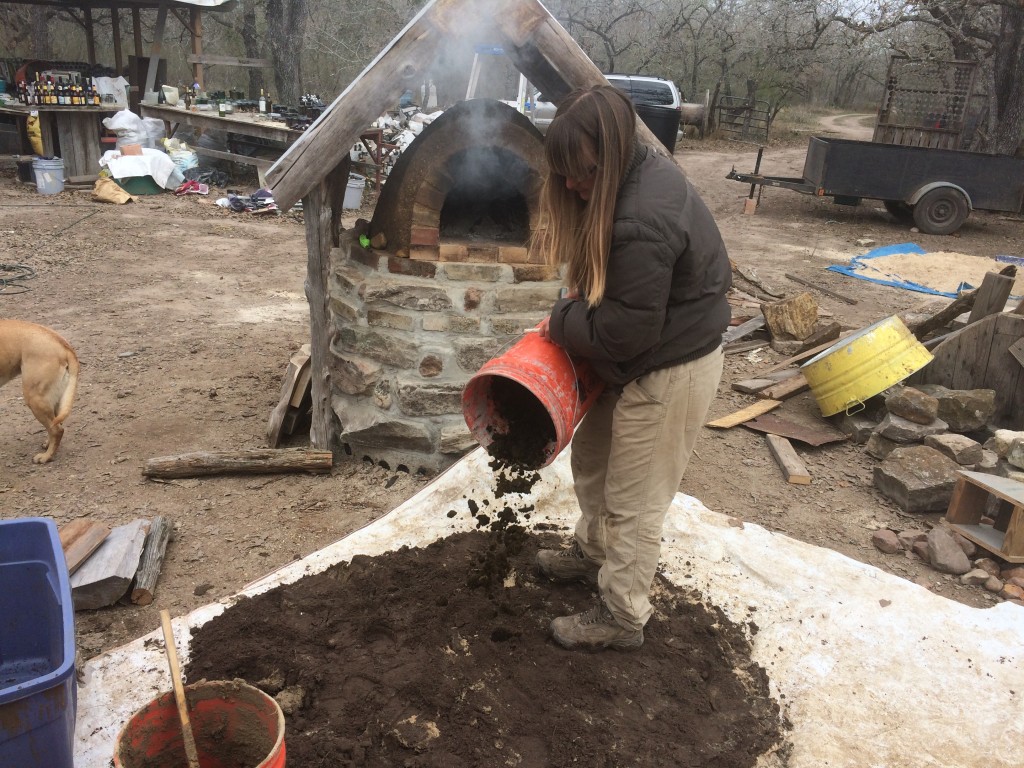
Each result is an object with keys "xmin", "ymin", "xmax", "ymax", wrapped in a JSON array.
[{"xmin": 267, "ymin": 0, "xmax": 659, "ymax": 210}]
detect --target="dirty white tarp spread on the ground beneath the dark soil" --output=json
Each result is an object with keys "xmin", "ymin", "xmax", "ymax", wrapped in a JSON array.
[{"xmin": 75, "ymin": 450, "xmax": 1024, "ymax": 768}]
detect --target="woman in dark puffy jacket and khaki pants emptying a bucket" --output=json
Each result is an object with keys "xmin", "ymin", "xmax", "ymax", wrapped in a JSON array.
[{"xmin": 537, "ymin": 86, "xmax": 731, "ymax": 649}]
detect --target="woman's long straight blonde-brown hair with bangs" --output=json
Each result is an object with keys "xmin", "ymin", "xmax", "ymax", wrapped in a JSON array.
[{"xmin": 541, "ymin": 85, "xmax": 636, "ymax": 306}]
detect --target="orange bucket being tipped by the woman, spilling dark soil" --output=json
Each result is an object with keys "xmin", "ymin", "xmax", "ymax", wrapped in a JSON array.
[{"xmin": 462, "ymin": 333, "xmax": 604, "ymax": 469}]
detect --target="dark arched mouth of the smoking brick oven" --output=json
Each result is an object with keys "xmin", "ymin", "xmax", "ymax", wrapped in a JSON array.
[{"xmin": 438, "ymin": 146, "xmax": 530, "ymax": 245}]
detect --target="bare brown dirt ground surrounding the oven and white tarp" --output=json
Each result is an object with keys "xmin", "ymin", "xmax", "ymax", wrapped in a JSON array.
[{"xmin": 0, "ymin": 116, "xmax": 1024, "ymax": 671}]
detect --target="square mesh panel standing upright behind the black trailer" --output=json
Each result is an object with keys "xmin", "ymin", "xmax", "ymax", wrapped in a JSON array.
[{"xmin": 872, "ymin": 56, "xmax": 978, "ymax": 150}]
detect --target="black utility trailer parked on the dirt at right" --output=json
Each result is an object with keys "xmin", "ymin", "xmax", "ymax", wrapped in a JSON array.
[{"xmin": 726, "ymin": 136, "xmax": 1024, "ymax": 234}]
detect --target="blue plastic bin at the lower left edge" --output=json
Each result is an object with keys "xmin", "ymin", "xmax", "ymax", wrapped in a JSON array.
[{"xmin": 0, "ymin": 517, "xmax": 78, "ymax": 768}]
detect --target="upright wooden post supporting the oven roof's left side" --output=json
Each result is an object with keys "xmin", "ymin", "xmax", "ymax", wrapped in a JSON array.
[{"xmin": 302, "ymin": 155, "xmax": 351, "ymax": 452}]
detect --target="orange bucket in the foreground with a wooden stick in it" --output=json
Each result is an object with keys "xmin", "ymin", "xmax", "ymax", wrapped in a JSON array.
[{"xmin": 114, "ymin": 680, "xmax": 285, "ymax": 768}]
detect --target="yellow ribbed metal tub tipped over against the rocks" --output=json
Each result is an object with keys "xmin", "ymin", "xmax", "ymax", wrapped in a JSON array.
[{"xmin": 801, "ymin": 315, "xmax": 932, "ymax": 416}]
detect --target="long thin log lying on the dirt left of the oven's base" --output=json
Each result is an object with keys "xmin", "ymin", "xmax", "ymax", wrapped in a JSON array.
[{"xmin": 142, "ymin": 449, "xmax": 334, "ymax": 478}]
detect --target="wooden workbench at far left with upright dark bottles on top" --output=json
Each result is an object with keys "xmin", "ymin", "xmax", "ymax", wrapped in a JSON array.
[{"xmin": 0, "ymin": 104, "xmax": 124, "ymax": 182}]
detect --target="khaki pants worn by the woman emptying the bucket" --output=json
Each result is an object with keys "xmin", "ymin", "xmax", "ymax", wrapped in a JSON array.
[{"xmin": 571, "ymin": 348, "xmax": 725, "ymax": 630}]
